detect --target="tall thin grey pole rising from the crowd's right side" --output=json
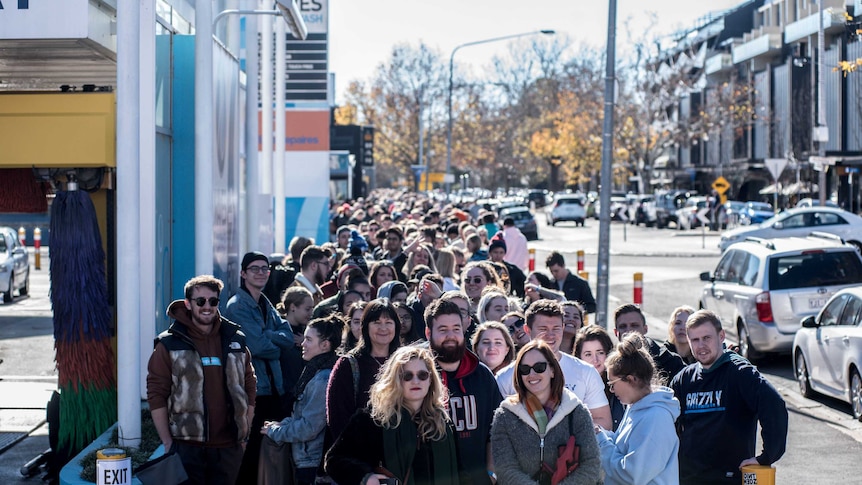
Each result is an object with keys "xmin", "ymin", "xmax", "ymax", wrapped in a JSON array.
[{"xmin": 596, "ymin": 0, "xmax": 617, "ymax": 329}]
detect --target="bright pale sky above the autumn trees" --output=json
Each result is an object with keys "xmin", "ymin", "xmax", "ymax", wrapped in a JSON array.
[{"xmin": 329, "ymin": 0, "xmax": 747, "ymax": 99}]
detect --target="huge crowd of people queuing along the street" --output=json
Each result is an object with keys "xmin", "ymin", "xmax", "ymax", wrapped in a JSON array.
[{"xmin": 147, "ymin": 192, "xmax": 787, "ymax": 485}]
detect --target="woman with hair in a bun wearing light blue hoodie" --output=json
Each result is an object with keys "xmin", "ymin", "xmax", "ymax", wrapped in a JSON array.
[{"xmin": 596, "ymin": 332, "xmax": 680, "ymax": 484}]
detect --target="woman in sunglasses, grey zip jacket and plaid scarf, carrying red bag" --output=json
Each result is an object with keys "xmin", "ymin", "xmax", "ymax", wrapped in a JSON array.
[{"xmin": 491, "ymin": 340, "xmax": 601, "ymax": 485}]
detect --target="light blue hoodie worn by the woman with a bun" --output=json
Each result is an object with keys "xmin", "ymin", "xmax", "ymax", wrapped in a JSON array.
[{"xmin": 596, "ymin": 387, "xmax": 679, "ymax": 485}]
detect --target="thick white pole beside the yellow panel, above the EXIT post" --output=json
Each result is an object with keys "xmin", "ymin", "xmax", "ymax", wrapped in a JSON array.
[{"xmin": 117, "ymin": 2, "xmax": 142, "ymax": 446}]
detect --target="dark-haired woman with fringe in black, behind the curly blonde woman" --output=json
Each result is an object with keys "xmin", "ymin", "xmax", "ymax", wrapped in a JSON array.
[{"xmin": 326, "ymin": 298, "xmax": 401, "ymax": 440}]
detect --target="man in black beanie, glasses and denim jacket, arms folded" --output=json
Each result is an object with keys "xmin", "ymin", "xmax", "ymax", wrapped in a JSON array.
[{"xmin": 225, "ymin": 251, "xmax": 296, "ymax": 483}]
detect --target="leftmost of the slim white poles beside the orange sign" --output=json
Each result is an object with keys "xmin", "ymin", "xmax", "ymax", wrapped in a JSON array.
[{"xmin": 243, "ymin": 0, "xmax": 260, "ymax": 253}]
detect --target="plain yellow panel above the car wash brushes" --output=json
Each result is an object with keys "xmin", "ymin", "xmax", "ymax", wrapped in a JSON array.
[{"xmin": 0, "ymin": 93, "xmax": 117, "ymax": 168}]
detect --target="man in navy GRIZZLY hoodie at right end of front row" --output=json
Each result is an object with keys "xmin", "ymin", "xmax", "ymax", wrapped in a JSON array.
[{"xmin": 670, "ymin": 310, "xmax": 788, "ymax": 485}]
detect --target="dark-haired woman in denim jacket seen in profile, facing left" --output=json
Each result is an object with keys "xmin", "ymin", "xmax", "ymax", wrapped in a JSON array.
[{"xmin": 260, "ymin": 314, "xmax": 344, "ymax": 485}]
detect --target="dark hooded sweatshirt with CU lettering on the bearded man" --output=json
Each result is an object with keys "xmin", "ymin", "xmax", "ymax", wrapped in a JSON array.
[{"xmin": 440, "ymin": 350, "xmax": 503, "ymax": 485}]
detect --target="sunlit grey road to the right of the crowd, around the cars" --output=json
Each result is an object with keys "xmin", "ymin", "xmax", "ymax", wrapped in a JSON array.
[{"xmin": 531, "ymin": 212, "xmax": 862, "ymax": 484}]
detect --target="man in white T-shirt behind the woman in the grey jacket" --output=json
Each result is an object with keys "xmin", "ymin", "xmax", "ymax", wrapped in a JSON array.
[{"xmin": 497, "ymin": 300, "xmax": 612, "ymax": 429}]
